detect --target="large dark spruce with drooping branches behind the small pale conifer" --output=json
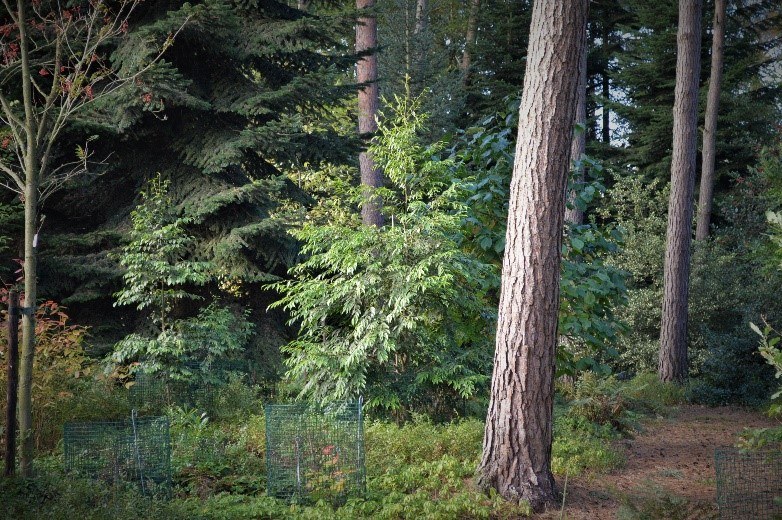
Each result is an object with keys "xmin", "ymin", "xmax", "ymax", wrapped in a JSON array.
[{"xmin": 27, "ymin": 0, "xmax": 354, "ymax": 354}]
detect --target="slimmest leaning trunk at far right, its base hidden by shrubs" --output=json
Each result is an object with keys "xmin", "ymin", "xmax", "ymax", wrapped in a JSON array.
[{"xmin": 695, "ymin": 0, "xmax": 727, "ymax": 240}]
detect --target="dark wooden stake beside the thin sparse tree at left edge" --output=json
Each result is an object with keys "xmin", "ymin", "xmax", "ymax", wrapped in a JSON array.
[{"xmin": 4, "ymin": 290, "xmax": 19, "ymax": 477}]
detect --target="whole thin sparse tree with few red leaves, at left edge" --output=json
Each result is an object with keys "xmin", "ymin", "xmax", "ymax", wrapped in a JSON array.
[{"xmin": 0, "ymin": 0, "xmax": 185, "ymax": 477}]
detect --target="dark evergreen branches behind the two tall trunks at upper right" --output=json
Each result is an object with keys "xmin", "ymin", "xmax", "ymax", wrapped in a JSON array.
[{"xmin": 609, "ymin": 0, "xmax": 780, "ymax": 180}]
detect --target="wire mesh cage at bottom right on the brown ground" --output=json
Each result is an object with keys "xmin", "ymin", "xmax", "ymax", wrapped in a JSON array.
[{"xmin": 714, "ymin": 448, "xmax": 782, "ymax": 520}]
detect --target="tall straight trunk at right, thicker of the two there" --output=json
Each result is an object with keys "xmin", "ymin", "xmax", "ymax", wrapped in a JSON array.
[{"xmin": 659, "ymin": 0, "xmax": 702, "ymax": 381}]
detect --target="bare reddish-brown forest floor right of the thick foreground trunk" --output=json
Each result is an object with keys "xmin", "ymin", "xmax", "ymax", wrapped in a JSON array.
[{"xmin": 539, "ymin": 405, "xmax": 774, "ymax": 520}]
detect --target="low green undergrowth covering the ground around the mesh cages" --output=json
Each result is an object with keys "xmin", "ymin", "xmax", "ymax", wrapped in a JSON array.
[{"xmin": 0, "ymin": 374, "xmax": 682, "ymax": 519}]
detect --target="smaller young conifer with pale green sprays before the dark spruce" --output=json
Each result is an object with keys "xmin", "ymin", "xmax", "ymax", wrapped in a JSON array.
[{"xmin": 112, "ymin": 177, "xmax": 251, "ymax": 380}]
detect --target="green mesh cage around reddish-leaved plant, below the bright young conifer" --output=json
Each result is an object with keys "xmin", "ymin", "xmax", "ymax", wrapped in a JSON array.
[{"xmin": 265, "ymin": 400, "xmax": 366, "ymax": 505}]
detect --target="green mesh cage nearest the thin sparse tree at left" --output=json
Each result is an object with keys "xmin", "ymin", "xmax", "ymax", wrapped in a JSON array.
[{"xmin": 63, "ymin": 412, "xmax": 171, "ymax": 496}]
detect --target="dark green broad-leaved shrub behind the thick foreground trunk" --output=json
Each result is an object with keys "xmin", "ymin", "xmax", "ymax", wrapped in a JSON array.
[{"xmin": 453, "ymin": 100, "xmax": 626, "ymax": 375}]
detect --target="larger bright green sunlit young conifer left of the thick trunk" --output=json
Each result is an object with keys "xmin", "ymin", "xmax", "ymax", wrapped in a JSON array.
[{"xmin": 273, "ymin": 93, "xmax": 497, "ymax": 413}]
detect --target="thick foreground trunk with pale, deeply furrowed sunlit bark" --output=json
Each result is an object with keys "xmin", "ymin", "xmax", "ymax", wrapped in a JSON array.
[{"xmin": 478, "ymin": 0, "xmax": 588, "ymax": 510}]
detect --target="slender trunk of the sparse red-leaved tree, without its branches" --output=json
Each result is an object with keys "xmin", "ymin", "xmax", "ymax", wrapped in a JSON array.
[{"xmin": 17, "ymin": 0, "xmax": 40, "ymax": 477}]
